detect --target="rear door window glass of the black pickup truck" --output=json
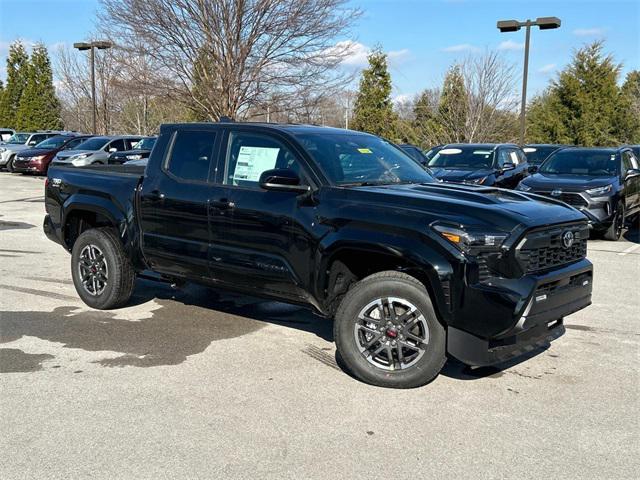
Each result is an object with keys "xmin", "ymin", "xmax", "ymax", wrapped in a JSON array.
[{"xmin": 165, "ymin": 130, "xmax": 216, "ymax": 182}]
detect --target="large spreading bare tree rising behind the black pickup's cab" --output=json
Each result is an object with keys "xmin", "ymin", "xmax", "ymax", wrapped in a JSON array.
[{"xmin": 101, "ymin": 0, "xmax": 360, "ymax": 120}]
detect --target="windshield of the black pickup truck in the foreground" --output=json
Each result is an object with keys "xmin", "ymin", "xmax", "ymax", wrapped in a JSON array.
[{"xmin": 297, "ymin": 133, "xmax": 435, "ymax": 185}]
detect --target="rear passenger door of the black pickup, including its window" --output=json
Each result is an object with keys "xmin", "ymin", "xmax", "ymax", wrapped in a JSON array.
[{"xmin": 140, "ymin": 129, "xmax": 219, "ymax": 279}]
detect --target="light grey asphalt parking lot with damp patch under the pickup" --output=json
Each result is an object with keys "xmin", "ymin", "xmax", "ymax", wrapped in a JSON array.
[{"xmin": 0, "ymin": 173, "xmax": 640, "ymax": 479}]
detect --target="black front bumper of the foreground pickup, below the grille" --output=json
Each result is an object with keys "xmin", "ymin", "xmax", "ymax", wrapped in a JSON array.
[{"xmin": 447, "ymin": 259, "xmax": 593, "ymax": 366}]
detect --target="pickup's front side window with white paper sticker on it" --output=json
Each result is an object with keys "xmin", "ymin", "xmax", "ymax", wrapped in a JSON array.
[{"xmin": 223, "ymin": 132, "xmax": 302, "ymax": 188}]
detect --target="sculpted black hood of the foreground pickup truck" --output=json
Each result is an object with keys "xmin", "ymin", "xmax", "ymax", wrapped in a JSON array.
[{"xmin": 345, "ymin": 183, "xmax": 585, "ymax": 232}]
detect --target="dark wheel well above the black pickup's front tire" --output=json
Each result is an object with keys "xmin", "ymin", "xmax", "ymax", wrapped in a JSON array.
[{"xmin": 324, "ymin": 249, "xmax": 435, "ymax": 314}]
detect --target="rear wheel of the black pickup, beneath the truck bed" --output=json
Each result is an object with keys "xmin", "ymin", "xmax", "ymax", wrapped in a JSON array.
[{"xmin": 71, "ymin": 228, "xmax": 136, "ymax": 310}]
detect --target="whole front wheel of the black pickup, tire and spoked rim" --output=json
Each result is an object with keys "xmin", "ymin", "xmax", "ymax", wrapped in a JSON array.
[{"xmin": 334, "ymin": 271, "xmax": 446, "ymax": 388}]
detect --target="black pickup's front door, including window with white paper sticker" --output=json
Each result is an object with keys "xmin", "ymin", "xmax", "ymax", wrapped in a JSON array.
[{"xmin": 210, "ymin": 127, "xmax": 316, "ymax": 299}]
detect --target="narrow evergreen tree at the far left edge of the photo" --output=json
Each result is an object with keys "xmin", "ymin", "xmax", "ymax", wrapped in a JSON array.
[{"xmin": 0, "ymin": 40, "xmax": 29, "ymax": 128}]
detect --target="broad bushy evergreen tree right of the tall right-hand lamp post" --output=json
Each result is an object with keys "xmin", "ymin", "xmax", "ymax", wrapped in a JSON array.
[{"xmin": 527, "ymin": 42, "xmax": 637, "ymax": 146}]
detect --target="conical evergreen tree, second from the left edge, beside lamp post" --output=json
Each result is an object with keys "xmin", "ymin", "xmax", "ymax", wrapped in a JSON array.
[{"xmin": 16, "ymin": 44, "xmax": 62, "ymax": 130}]
